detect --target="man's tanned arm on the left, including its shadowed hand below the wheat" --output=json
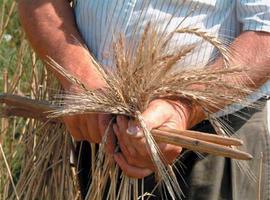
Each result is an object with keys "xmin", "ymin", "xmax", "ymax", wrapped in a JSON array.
[{"xmin": 18, "ymin": 0, "xmax": 115, "ymax": 143}]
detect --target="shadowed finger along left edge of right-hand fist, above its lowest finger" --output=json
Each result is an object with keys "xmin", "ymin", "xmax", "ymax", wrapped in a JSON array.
[{"xmin": 116, "ymin": 115, "xmax": 136, "ymax": 156}]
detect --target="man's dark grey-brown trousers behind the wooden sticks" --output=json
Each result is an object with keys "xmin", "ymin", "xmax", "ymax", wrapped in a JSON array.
[{"xmin": 76, "ymin": 100, "xmax": 270, "ymax": 200}]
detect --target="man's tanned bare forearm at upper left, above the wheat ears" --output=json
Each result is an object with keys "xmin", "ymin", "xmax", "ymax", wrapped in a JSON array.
[{"xmin": 18, "ymin": 0, "xmax": 102, "ymax": 88}]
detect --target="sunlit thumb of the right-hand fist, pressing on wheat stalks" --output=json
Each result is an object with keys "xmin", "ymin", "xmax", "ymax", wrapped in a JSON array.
[{"xmin": 127, "ymin": 100, "xmax": 172, "ymax": 137}]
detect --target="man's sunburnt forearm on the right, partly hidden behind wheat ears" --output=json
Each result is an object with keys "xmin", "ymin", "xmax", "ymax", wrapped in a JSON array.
[{"xmin": 186, "ymin": 31, "xmax": 270, "ymax": 128}]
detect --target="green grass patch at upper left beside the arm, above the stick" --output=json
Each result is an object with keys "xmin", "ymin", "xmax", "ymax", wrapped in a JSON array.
[{"xmin": 0, "ymin": 0, "xmax": 34, "ymax": 92}]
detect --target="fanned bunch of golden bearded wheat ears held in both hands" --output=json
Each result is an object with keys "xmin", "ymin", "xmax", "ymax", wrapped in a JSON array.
[{"xmin": 43, "ymin": 23, "xmax": 262, "ymax": 198}]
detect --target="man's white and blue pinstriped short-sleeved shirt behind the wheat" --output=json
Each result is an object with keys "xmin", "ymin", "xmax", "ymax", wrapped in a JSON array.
[{"xmin": 75, "ymin": 0, "xmax": 270, "ymax": 114}]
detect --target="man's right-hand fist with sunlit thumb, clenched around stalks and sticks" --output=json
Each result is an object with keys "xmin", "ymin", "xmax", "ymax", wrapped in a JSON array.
[{"xmin": 113, "ymin": 99, "xmax": 194, "ymax": 178}]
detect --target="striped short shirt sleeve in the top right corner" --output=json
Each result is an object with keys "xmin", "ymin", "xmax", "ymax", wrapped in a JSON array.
[{"xmin": 236, "ymin": 0, "xmax": 270, "ymax": 32}]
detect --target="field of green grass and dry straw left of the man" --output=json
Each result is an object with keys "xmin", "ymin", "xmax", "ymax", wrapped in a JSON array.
[{"xmin": 0, "ymin": 0, "xmax": 79, "ymax": 200}]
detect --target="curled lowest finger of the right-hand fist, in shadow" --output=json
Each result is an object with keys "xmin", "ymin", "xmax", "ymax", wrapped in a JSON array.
[{"xmin": 114, "ymin": 153, "xmax": 152, "ymax": 179}]
